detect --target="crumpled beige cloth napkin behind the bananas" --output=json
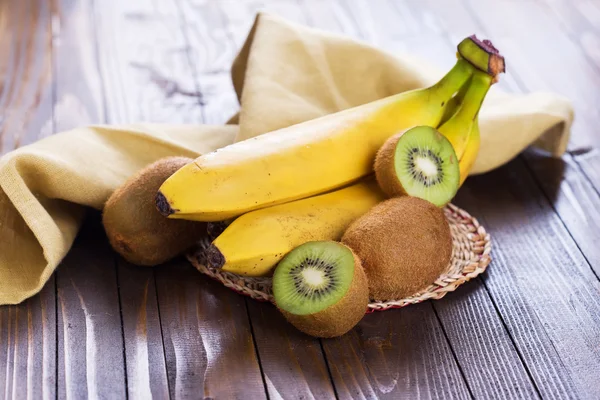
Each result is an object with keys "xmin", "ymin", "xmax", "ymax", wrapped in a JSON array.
[{"xmin": 0, "ymin": 14, "xmax": 573, "ymax": 304}]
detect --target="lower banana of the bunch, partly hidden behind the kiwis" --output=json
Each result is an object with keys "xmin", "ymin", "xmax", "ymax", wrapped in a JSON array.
[{"xmin": 205, "ymin": 177, "xmax": 385, "ymax": 276}]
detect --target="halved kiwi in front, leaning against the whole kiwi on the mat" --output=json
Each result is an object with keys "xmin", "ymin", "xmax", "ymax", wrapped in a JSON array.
[{"xmin": 273, "ymin": 241, "xmax": 369, "ymax": 337}]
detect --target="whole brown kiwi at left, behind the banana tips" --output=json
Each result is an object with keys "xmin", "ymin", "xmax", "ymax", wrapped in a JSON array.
[{"xmin": 102, "ymin": 157, "xmax": 206, "ymax": 266}]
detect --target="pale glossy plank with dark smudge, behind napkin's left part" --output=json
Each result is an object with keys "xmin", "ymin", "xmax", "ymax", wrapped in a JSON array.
[{"xmin": 94, "ymin": 0, "xmax": 202, "ymax": 123}]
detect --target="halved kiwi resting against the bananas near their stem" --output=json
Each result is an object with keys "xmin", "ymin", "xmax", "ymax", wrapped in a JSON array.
[{"xmin": 375, "ymin": 126, "xmax": 460, "ymax": 207}]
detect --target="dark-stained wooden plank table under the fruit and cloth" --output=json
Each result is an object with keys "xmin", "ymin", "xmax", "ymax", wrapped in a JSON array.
[{"xmin": 0, "ymin": 0, "xmax": 600, "ymax": 399}]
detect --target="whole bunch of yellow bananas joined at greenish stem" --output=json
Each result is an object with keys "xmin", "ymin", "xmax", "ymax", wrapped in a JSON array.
[{"xmin": 156, "ymin": 37, "xmax": 504, "ymax": 276}]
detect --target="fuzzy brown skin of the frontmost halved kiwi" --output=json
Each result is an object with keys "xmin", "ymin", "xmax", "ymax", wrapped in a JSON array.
[{"xmin": 279, "ymin": 253, "xmax": 369, "ymax": 338}]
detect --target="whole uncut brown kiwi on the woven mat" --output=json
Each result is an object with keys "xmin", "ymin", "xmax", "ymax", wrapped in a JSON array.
[{"xmin": 342, "ymin": 196, "xmax": 452, "ymax": 301}]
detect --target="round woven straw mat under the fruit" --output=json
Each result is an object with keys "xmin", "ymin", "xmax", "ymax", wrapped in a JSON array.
[{"xmin": 188, "ymin": 204, "xmax": 491, "ymax": 312}]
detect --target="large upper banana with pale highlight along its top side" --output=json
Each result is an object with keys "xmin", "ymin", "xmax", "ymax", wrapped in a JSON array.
[{"xmin": 156, "ymin": 58, "xmax": 476, "ymax": 221}]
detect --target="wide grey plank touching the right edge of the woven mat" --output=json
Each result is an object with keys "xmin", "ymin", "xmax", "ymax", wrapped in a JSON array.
[{"xmin": 458, "ymin": 160, "xmax": 600, "ymax": 398}]
